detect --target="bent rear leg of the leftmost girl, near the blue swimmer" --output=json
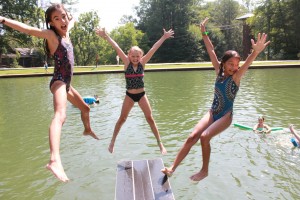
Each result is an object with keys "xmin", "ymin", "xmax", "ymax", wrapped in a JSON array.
[{"xmin": 68, "ymin": 86, "xmax": 99, "ymax": 140}]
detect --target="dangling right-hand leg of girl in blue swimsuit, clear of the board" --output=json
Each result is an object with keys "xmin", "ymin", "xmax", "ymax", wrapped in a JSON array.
[{"xmin": 190, "ymin": 112, "xmax": 232, "ymax": 181}]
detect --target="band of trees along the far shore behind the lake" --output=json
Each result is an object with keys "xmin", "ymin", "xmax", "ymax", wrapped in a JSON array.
[{"xmin": 0, "ymin": 0, "xmax": 300, "ymax": 66}]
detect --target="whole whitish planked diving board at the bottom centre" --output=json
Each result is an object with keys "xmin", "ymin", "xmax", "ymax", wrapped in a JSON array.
[{"xmin": 115, "ymin": 158, "xmax": 175, "ymax": 200}]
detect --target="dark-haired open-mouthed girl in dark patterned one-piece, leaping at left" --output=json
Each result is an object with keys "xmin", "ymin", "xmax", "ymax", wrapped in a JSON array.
[{"xmin": 0, "ymin": 4, "xmax": 99, "ymax": 182}]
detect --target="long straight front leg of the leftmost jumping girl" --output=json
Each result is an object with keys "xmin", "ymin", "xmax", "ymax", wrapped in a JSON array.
[{"xmin": 46, "ymin": 81, "xmax": 69, "ymax": 182}]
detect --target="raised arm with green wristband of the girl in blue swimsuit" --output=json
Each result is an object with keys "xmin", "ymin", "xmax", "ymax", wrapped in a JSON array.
[{"xmin": 200, "ymin": 17, "xmax": 220, "ymax": 74}]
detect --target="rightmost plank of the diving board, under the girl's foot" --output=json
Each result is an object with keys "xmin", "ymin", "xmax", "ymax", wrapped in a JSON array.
[{"xmin": 148, "ymin": 158, "xmax": 175, "ymax": 200}]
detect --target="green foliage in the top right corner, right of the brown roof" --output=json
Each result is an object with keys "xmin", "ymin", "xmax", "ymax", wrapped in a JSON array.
[{"xmin": 250, "ymin": 0, "xmax": 300, "ymax": 59}]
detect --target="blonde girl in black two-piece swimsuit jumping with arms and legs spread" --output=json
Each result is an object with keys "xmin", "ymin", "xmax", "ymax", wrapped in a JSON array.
[{"xmin": 96, "ymin": 28, "xmax": 174, "ymax": 154}]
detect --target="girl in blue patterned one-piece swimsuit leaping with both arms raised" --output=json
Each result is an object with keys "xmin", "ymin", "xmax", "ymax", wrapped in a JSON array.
[{"xmin": 161, "ymin": 18, "xmax": 270, "ymax": 181}]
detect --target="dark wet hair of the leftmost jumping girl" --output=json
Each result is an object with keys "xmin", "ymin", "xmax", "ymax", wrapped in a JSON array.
[{"xmin": 44, "ymin": 3, "xmax": 71, "ymax": 57}]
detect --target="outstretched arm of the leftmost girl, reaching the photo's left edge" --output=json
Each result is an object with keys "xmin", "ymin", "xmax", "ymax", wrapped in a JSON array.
[{"xmin": 0, "ymin": 16, "xmax": 55, "ymax": 39}]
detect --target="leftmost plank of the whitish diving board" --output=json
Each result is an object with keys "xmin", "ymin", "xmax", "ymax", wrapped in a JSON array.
[{"xmin": 115, "ymin": 161, "xmax": 134, "ymax": 200}]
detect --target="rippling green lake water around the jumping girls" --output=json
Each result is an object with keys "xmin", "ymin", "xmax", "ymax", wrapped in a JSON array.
[{"xmin": 0, "ymin": 69, "xmax": 300, "ymax": 200}]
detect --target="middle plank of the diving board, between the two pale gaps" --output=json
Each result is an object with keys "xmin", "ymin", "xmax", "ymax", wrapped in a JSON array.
[{"xmin": 132, "ymin": 160, "xmax": 154, "ymax": 200}]
